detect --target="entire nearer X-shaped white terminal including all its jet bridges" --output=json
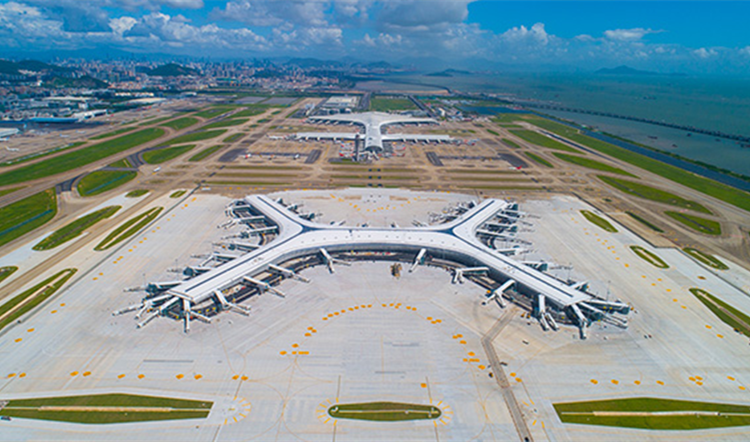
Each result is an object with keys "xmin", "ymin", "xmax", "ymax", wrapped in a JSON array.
[{"xmin": 113, "ymin": 195, "xmax": 630, "ymax": 339}]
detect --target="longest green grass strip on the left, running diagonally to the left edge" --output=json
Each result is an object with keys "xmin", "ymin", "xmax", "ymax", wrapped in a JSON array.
[{"xmin": 0, "ymin": 129, "xmax": 164, "ymax": 186}]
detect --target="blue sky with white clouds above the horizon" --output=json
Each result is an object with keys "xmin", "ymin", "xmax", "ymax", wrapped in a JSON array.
[{"xmin": 0, "ymin": 0, "xmax": 750, "ymax": 74}]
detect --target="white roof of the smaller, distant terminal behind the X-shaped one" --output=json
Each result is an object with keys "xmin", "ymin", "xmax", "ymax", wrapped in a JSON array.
[{"xmin": 297, "ymin": 112, "xmax": 451, "ymax": 150}]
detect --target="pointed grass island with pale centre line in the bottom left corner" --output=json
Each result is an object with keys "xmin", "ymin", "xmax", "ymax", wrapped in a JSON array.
[{"xmin": 0, "ymin": 394, "xmax": 213, "ymax": 424}]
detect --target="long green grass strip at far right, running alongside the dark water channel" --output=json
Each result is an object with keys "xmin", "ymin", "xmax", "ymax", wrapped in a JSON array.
[{"xmin": 527, "ymin": 117, "xmax": 750, "ymax": 211}]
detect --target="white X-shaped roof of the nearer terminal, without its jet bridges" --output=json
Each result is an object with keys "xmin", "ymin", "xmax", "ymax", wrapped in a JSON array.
[{"xmin": 168, "ymin": 195, "xmax": 592, "ymax": 308}]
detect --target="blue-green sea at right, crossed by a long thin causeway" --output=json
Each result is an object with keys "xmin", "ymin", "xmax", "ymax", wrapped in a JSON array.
[{"xmin": 376, "ymin": 73, "xmax": 750, "ymax": 176}]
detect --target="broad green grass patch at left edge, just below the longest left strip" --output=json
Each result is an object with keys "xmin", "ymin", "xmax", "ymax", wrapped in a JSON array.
[{"xmin": 0, "ymin": 189, "xmax": 57, "ymax": 246}]
